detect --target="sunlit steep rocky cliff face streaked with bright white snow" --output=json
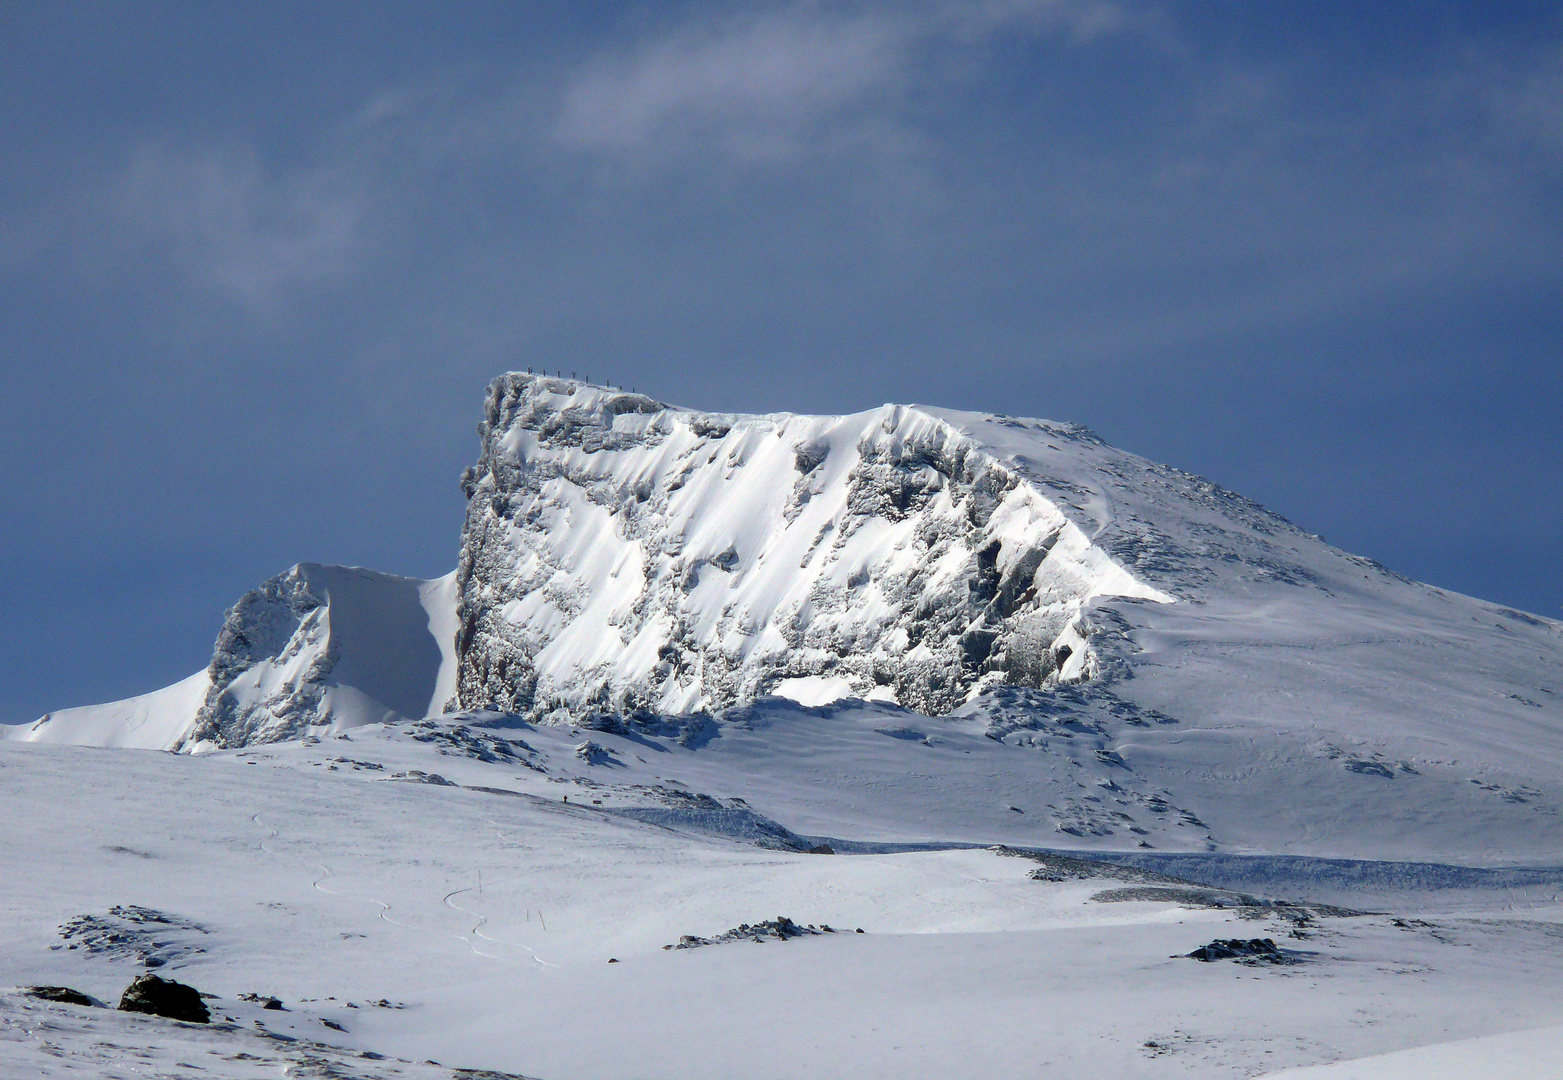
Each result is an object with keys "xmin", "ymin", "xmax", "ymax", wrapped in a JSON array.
[{"xmin": 453, "ymin": 374, "xmax": 1171, "ymax": 719}]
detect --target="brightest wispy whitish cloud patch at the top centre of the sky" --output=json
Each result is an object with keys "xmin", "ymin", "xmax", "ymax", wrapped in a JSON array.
[{"xmin": 553, "ymin": 0, "xmax": 1128, "ymax": 161}]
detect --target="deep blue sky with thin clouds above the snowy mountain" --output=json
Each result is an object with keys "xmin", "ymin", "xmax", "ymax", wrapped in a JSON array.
[{"xmin": 0, "ymin": 0, "xmax": 1563, "ymax": 721}]
